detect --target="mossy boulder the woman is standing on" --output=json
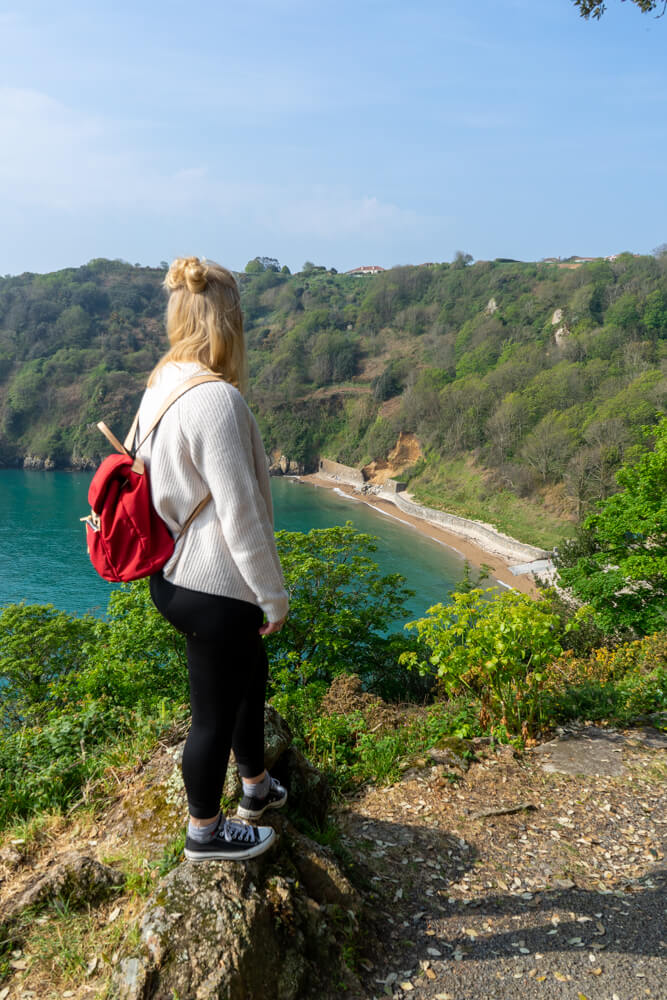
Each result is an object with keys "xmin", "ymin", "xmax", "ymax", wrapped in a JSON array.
[{"xmin": 111, "ymin": 706, "xmax": 360, "ymax": 1000}]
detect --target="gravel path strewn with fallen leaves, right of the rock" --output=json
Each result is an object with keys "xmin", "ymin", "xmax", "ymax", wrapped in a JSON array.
[{"xmin": 340, "ymin": 728, "xmax": 667, "ymax": 1000}]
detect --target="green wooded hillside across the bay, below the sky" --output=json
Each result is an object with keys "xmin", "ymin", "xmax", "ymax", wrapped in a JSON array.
[{"xmin": 0, "ymin": 254, "xmax": 667, "ymax": 541}]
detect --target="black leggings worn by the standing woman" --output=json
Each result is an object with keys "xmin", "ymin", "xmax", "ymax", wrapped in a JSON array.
[{"xmin": 150, "ymin": 573, "xmax": 268, "ymax": 819}]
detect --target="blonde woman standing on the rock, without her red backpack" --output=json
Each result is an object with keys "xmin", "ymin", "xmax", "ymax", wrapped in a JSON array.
[{"xmin": 138, "ymin": 257, "xmax": 288, "ymax": 861}]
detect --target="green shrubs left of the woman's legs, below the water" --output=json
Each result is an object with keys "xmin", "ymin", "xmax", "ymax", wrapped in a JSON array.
[{"xmin": 0, "ymin": 581, "xmax": 187, "ymax": 827}]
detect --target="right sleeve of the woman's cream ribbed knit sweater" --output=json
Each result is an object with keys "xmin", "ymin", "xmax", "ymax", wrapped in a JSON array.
[{"xmin": 181, "ymin": 383, "xmax": 288, "ymax": 621}]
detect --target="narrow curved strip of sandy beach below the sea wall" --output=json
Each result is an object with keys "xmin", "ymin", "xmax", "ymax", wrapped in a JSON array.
[{"xmin": 295, "ymin": 473, "xmax": 538, "ymax": 597}]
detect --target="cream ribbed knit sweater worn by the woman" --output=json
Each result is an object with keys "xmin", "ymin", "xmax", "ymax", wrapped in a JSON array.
[{"xmin": 137, "ymin": 362, "xmax": 288, "ymax": 622}]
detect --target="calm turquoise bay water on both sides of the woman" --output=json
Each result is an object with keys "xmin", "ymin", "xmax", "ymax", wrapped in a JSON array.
[{"xmin": 0, "ymin": 469, "xmax": 472, "ymax": 617}]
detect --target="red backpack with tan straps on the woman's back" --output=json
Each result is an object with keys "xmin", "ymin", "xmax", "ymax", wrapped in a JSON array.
[{"xmin": 81, "ymin": 375, "xmax": 221, "ymax": 583}]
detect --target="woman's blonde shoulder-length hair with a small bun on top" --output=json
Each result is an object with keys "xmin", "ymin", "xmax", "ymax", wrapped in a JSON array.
[{"xmin": 148, "ymin": 257, "xmax": 248, "ymax": 392}]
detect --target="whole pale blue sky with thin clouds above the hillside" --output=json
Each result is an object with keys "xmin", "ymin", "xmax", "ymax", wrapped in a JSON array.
[{"xmin": 0, "ymin": 0, "xmax": 667, "ymax": 274}]
